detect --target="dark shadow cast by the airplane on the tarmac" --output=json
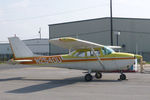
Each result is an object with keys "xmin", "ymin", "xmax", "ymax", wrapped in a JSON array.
[{"xmin": 3, "ymin": 77, "xmax": 120, "ymax": 94}]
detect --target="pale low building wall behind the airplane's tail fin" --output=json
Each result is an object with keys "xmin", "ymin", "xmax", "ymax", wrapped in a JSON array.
[{"xmin": 0, "ymin": 39, "xmax": 49, "ymax": 60}]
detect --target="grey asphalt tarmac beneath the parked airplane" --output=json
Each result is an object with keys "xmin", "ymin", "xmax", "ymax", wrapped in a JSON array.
[{"xmin": 0, "ymin": 64, "xmax": 150, "ymax": 100}]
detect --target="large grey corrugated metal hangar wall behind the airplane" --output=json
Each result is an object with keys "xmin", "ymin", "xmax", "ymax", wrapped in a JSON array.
[{"xmin": 49, "ymin": 18, "xmax": 150, "ymax": 61}]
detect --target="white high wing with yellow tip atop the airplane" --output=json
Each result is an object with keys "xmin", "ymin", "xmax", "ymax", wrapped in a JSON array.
[{"xmin": 49, "ymin": 37, "xmax": 120, "ymax": 49}]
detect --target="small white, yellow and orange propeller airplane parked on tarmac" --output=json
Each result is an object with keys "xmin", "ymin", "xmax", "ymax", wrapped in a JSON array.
[{"xmin": 8, "ymin": 37, "xmax": 142, "ymax": 81}]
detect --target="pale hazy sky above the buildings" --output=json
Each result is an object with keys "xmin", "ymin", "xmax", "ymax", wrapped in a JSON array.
[{"xmin": 0, "ymin": 0, "xmax": 150, "ymax": 43}]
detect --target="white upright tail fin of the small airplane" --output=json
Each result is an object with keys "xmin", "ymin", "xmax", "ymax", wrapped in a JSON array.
[{"xmin": 8, "ymin": 37, "xmax": 34, "ymax": 58}]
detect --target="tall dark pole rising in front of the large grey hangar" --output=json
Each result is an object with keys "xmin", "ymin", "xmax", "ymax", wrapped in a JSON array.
[{"xmin": 110, "ymin": 0, "xmax": 113, "ymax": 46}]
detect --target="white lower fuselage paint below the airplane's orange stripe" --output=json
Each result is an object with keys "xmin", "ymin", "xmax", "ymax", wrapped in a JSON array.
[{"xmin": 37, "ymin": 59, "xmax": 134, "ymax": 71}]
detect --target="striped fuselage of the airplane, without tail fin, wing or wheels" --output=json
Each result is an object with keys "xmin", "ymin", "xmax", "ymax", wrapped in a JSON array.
[{"xmin": 15, "ymin": 52, "xmax": 136, "ymax": 71}]
